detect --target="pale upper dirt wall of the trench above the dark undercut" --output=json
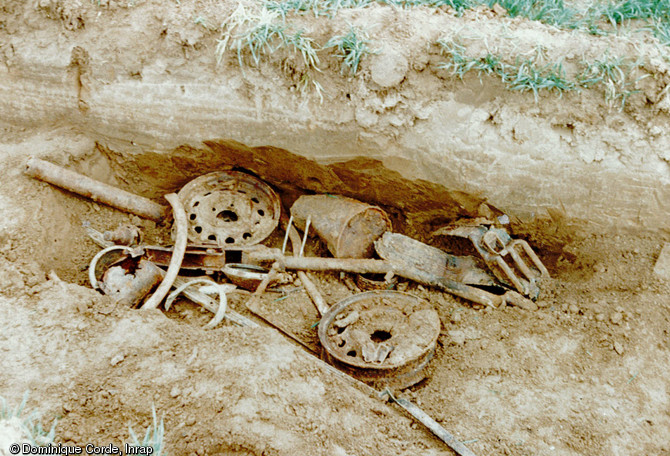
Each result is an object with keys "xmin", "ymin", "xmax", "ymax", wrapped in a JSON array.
[{"xmin": 0, "ymin": 0, "xmax": 670, "ymax": 229}]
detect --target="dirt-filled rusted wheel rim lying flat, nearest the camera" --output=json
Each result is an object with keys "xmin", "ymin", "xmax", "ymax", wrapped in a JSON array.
[{"xmin": 318, "ymin": 291, "xmax": 440, "ymax": 388}]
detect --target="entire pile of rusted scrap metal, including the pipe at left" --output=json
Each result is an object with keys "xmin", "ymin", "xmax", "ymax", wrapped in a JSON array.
[{"xmin": 26, "ymin": 159, "xmax": 549, "ymax": 454}]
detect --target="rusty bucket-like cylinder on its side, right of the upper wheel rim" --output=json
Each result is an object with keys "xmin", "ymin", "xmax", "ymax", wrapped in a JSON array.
[{"xmin": 291, "ymin": 195, "xmax": 391, "ymax": 258}]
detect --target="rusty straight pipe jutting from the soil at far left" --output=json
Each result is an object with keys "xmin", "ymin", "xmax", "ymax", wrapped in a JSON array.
[{"xmin": 25, "ymin": 158, "xmax": 167, "ymax": 222}]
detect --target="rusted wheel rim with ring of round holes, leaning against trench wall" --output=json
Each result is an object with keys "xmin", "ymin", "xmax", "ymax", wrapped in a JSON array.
[{"xmin": 178, "ymin": 171, "xmax": 281, "ymax": 246}]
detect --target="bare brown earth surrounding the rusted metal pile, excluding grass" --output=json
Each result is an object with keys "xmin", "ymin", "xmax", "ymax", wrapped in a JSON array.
[{"xmin": 0, "ymin": 0, "xmax": 670, "ymax": 455}]
